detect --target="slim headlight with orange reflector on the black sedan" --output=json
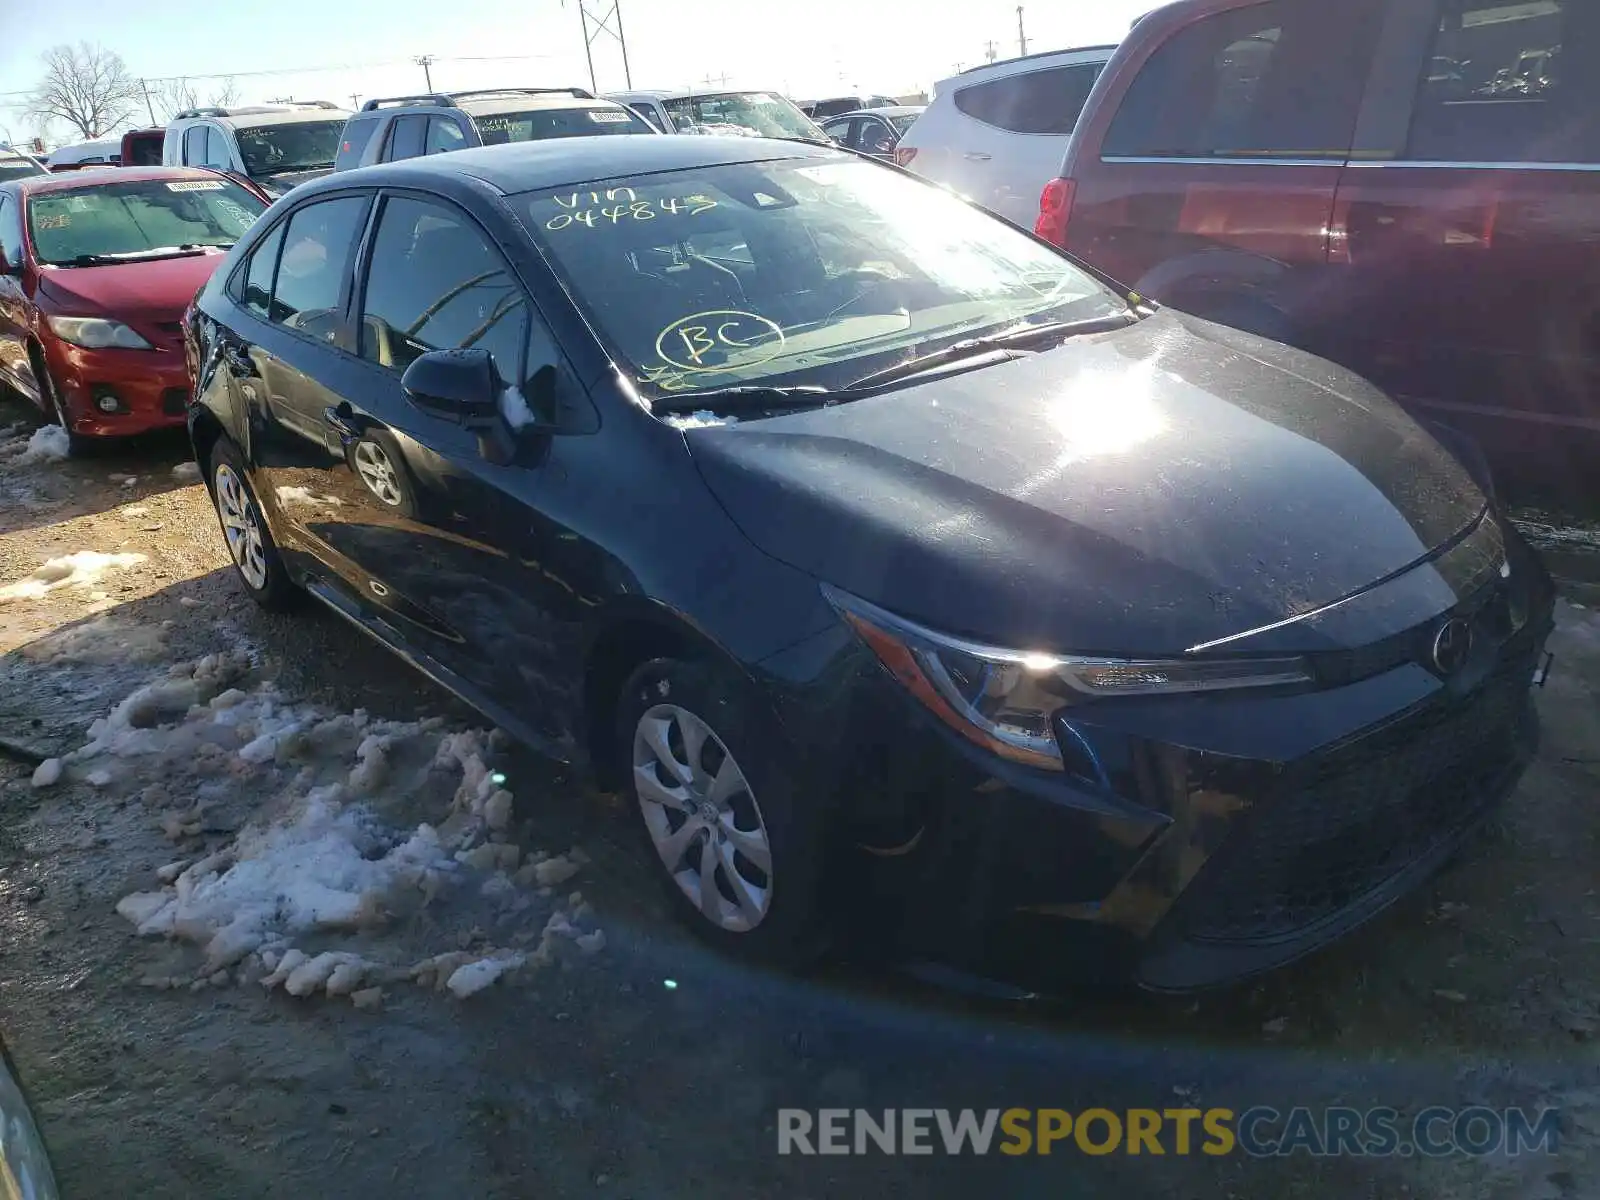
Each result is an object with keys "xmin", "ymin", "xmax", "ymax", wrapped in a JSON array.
[{"xmin": 822, "ymin": 584, "xmax": 1312, "ymax": 771}]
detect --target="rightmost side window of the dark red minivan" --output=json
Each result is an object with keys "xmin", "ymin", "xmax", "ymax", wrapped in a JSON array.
[{"xmin": 1406, "ymin": 0, "xmax": 1574, "ymax": 163}]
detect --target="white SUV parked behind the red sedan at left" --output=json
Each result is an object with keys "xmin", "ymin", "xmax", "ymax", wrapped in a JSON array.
[{"xmin": 162, "ymin": 101, "xmax": 350, "ymax": 200}]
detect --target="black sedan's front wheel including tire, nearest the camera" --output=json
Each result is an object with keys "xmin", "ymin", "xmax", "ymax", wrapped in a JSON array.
[{"xmin": 618, "ymin": 659, "xmax": 827, "ymax": 966}]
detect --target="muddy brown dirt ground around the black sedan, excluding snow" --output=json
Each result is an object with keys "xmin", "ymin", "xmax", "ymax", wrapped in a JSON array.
[{"xmin": 0, "ymin": 392, "xmax": 1600, "ymax": 1200}]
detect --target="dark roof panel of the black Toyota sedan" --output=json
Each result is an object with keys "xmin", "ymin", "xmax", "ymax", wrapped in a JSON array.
[{"xmin": 320, "ymin": 136, "xmax": 856, "ymax": 195}]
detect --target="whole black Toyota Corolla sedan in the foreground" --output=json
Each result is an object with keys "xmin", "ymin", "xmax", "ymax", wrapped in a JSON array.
[{"xmin": 187, "ymin": 138, "xmax": 1552, "ymax": 989}]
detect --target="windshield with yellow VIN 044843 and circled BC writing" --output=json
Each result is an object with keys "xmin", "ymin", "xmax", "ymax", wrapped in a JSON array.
[{"xmin": 523, "ymin": 157, "xmax": 1126, "ymax": 404}]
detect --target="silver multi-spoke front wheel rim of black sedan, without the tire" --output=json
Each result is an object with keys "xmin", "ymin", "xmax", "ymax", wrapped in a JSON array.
[{"xmin": 634, "ymin": 704, "xmax": 773, "ymax": 933}]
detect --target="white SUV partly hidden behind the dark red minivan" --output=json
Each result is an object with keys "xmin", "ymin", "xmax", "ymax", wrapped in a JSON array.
[{"xmin": 894, "ymin": 46, "xmax": 1115, "ymax": 229}]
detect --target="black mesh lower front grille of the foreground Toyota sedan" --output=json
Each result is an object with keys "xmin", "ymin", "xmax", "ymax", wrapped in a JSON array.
[{"xmin": 1186, "ymin": 654, "xmax": 1533, "ymax": 942}]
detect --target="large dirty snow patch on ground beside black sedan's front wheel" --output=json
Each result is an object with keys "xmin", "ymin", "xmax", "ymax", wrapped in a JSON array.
[{"xmin": 62, "ymin": 654, "xmax": 605, "ymax": 1008}]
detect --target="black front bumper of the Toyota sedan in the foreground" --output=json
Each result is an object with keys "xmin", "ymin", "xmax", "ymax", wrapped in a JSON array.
[{"xmin": 774, "ymin": 512, "xmax": 1552, "ymax": 992}]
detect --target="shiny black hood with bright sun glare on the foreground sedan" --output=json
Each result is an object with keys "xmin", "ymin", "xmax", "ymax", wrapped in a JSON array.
[{"xmin": 685, "ymin": 310, "xmax": 1486, "ymax": 654}]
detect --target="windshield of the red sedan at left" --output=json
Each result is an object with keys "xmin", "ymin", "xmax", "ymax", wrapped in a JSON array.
[{"xmin": 27, "ymin": 174, "xmax": 266, "ymax": 266}]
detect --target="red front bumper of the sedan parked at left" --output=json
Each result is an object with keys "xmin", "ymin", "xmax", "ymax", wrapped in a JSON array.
[{"xmin": 46, "ymin": 338, "xmax": 189, "ymax": 437}]
